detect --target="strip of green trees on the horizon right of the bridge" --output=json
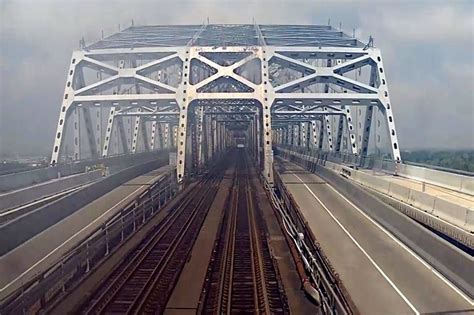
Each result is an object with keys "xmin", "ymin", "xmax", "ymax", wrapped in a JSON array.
[{"xmin": 402, "ymin": 150, "xmax": 474, "ymax": 172}]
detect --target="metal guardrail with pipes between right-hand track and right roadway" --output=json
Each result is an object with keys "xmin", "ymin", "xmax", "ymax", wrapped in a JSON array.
[{"xmin": 267, "ymin": 170, "xmax": 359, "ymax": 314}]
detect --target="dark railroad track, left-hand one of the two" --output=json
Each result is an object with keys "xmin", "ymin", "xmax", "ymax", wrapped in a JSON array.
[{"xmin": 82, "ymin": 163, "xmax": 225, "ymax": 314}]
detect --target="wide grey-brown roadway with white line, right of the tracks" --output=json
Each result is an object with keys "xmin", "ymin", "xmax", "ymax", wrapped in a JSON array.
[{"xmin": 277, "ymin": 160, "xmax": 473, "ymax": 314}]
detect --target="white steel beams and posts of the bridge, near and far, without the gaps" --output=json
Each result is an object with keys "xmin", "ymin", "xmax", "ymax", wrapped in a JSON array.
[{"xmin": 51, "ymin": 24, "xmax": 401, "ymax": 183}]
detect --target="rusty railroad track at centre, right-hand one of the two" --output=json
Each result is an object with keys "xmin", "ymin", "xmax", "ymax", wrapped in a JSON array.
[{"xmin": 199, "ymin": 154, "xmax": 289, "ymax": 314}]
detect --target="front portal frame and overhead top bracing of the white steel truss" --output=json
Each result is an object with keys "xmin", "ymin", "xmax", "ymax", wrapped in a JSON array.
[{"xmin": 51, "ymin": 24, "xmax": 400, "ymax": 182}]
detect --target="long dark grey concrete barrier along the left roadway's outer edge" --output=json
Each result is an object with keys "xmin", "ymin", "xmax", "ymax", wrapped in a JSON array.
[{"xmin": 0, "ymin": 156, "xmax": 168, "ymax": 255}]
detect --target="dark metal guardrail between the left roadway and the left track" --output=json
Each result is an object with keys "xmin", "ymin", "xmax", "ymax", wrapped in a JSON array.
[{"xmin": 0, "ymin": 171, "xmax": 178, "ymax": 314}]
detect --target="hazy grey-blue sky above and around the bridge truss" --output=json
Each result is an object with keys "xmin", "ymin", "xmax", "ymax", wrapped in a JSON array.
[{"xmin": 0, "ymin": 0, "xmax": 474, "ymax": 154}]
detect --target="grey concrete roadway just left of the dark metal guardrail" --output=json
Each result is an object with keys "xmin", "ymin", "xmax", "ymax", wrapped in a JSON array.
[{"xmin": 0, "ymin": 166, "xmax": 170, "ymax": 297}]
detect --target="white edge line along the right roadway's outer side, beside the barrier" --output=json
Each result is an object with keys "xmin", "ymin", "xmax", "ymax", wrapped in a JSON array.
[{"xmin": 328, "ymin": 178, "xmax": 474, "ymax": 305}]
